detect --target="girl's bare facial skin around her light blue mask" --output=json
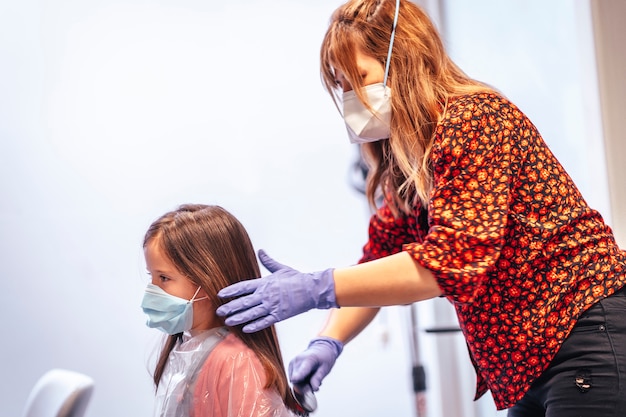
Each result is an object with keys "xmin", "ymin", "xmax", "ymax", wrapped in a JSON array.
[{"xmin": 144, "ymin": 239, "xmax": 222, "ymax": 333}]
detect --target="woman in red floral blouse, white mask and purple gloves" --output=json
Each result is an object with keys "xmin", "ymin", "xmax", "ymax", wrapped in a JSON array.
[{"xmin": 217, "ymin": 0, "xmax": 626, "ymax": 417}]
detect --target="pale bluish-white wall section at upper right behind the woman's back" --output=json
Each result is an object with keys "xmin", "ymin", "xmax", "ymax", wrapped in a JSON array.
[{"xmin": 445, "ymin": 0, "xmax": 610, "ymax": 220}]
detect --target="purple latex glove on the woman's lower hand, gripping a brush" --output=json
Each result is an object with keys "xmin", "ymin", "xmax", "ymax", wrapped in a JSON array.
[{"xmin": 289, "ymin": 336, "xmax": 343, "ymax": 391}]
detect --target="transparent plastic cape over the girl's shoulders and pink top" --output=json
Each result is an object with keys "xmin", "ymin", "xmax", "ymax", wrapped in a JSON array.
[{"xmin": 154, "ymin": 328, "xmax": 295, "ymax": 417}]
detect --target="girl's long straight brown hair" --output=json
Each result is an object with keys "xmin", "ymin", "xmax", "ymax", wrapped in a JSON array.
[{"xmin": 143, "ymin": 204, "xmax": 302, "ymax": 414}]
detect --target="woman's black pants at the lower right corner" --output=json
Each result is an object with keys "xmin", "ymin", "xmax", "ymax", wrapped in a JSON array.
[{"xmin": 507, "ymin": 290, "xmax": 626, "ymax": 417}]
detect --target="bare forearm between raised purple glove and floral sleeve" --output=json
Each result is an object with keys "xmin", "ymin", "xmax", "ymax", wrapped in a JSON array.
[{"xmin": 333, "ymin": 252, "xmax": 442, "ymax": 307}]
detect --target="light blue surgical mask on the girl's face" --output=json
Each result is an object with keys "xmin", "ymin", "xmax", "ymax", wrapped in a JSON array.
[{"xmin": 141, "ymin": 284, "xmax": 208, "ymax": 334}]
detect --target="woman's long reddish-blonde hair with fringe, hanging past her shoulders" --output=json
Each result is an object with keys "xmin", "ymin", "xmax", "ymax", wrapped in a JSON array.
[{"xmin": 320, "ymin": 0, "xmax": 493, "ymax": 213}]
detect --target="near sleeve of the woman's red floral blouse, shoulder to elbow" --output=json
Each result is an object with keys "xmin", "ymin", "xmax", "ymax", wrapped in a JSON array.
[{"xmin": 404, "ymin": 95, "xmax": 525, "ymax": 303}]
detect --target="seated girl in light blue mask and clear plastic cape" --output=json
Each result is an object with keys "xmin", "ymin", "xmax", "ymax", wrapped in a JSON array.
[{"xmin": 142, "ymin": 204, "xmax": 306, "ymax": 417}]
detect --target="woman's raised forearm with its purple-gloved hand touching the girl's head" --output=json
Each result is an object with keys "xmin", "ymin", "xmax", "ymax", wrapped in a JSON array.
[{"xmin": 217, "ymin": 252, "xmax": 442, "ymax": 333}]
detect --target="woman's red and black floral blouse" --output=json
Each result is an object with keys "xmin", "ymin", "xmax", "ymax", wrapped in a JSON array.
[{"xmin": 360, "ymin": 94, "xmax": 626, "ymax": 409}]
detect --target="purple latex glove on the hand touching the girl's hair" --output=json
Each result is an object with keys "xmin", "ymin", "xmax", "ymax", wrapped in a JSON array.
[{"xmin": 216, "ymin": 250, "xmax": 338, "ymax": 333}]
